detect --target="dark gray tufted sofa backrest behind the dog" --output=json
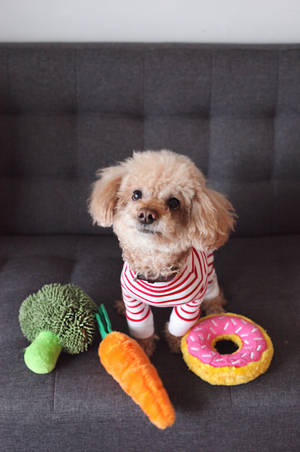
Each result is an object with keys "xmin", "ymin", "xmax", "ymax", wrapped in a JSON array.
[{"xmin": 0, "ymin": 44, "xmax": 300, "ymax": 236}]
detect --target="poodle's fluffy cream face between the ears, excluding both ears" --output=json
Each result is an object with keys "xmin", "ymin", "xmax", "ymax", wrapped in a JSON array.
[{"xmin": 113, "ymin": 153, "xmax": 194, "ymax": 246}]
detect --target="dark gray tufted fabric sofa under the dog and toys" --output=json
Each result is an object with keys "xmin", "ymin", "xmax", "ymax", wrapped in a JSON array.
[{"xmin": 0, "ymin": 44, "xmax": 300, "ymax": 452}]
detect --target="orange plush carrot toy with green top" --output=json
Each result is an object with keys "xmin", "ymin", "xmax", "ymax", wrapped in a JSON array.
[{"xmin": 96, "ymin": 305, "xmax": 175, "ymax": 429}]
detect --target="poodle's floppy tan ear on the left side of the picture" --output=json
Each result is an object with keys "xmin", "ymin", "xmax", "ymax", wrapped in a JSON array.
[{"xmin": 89, "ymin": 165, "xmax": 125, "ymax": 227}]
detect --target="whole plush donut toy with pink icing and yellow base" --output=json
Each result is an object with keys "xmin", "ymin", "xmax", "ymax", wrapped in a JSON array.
[{"xmin": 181, "ymin": 313, "xmax": 274, "ymax": 385}]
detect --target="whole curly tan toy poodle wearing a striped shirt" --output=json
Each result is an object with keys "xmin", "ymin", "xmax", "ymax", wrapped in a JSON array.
[{"xmin": 89, "ymin": 150, "xmax": 235, "ymax": 356}]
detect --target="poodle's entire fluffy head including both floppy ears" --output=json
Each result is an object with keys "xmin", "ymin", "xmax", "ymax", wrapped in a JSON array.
[{"xmin": 90, "ymin": 150, "xmax": 234, "ymax": 252}]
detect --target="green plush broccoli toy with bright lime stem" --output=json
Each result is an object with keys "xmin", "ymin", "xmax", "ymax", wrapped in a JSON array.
[{"xmin": 19, "ymin": 284, "xmax": 97, "ymax": 374}]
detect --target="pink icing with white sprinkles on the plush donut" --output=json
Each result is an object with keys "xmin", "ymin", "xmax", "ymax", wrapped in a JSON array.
[{"xmin": 186, "ymin": 314, "xmax": 267, "ymax": 367}]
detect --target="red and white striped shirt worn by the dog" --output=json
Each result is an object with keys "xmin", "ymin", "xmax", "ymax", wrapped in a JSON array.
[{"xmin": 121, "ymin": 248, "xmax": 219, "ymax": 338}]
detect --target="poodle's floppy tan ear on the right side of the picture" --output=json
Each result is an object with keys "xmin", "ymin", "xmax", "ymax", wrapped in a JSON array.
[{"xmin": 191, "ymin": 186, "xmax": 236, "ymax": 251}]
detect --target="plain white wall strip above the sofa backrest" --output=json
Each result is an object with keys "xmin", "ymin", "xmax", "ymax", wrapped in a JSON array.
[{"xmin": 0, "ymin": 0, "xmax": 300, "ymax": 43}]
